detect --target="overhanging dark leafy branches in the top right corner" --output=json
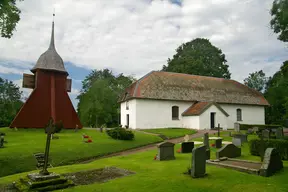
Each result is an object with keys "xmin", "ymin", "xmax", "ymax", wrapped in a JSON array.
[{"xmin": 270, "ymin": 0, "xmax": 288, "ymax": 42}]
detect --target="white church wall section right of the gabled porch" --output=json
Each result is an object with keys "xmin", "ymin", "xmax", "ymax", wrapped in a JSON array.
[{"xmin": 220, "ymin": 104, "xmax": 265, "ymax": 128}]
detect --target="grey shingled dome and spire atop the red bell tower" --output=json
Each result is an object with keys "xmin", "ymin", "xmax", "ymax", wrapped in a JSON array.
[{"xmin": 31, "ymin": 22, "xmax": 68, "ymax": 74}]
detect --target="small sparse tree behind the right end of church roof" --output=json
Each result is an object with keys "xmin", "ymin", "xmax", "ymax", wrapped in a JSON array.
[{"xmin": 244, "ymin": 70, "xmax": 268, "ymax": 92}]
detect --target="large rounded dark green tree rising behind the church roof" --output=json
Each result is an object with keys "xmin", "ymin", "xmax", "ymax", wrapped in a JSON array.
[{"xmin": 162, "ymin": 38, "xmax": 231, "ymax": 79}]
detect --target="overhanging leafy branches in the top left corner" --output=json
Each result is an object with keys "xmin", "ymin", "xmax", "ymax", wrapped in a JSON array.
[{"xmin": 0, "ymin": 0, "xmax": 23, "ymax": 38}]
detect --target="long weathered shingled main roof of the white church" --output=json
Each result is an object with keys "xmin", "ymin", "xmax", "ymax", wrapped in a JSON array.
[{"xmin": 119, "ymin": 71, "xmax": 269, "ymax": 105}]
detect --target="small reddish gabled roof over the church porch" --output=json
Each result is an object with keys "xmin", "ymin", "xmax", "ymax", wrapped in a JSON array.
[{"xmin": 182, "ymin": 102, "xmax": 229, "ymax": 117}]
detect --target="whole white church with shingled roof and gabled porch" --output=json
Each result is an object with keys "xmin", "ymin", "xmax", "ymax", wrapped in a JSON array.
[{"xmin": 119, "ymin": 71, "xmax": 269, "ymax": 129}]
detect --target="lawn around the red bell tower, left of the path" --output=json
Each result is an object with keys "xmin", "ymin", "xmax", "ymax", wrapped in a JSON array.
[{"xmin": 0, "ymin": 128, "xmax": 162, "ymax": 177}]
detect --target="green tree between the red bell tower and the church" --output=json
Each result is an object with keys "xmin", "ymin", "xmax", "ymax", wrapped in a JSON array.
[{"xmin": 77, "ymin": 69, "xmax": 135, "ymax": 127}]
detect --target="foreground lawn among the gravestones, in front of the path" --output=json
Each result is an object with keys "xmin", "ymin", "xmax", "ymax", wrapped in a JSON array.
[{"xmin": 0, "ymin": 132, "xmax": 288, "ymax": 192}]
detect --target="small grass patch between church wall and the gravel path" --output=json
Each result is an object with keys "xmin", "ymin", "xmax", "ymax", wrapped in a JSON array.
[{"xmin": 141, "ymin": 128, "xmax": 196, "ymax": 138}]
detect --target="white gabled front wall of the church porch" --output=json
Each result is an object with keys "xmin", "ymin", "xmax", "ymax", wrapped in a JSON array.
[{"xmin": 199, "ymin": 105, "xmax": 227, "ymax": 129}]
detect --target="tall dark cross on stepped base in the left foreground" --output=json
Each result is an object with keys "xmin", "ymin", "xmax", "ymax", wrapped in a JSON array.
[{"xmin": 39, "ymin": 118, "xmax": 55, "ymax": 175}]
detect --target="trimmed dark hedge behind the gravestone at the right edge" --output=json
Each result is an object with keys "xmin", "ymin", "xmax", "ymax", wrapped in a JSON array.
[{"xmin": 249, "ymin": 139, "xmax": 288, "ymax": 160}]
